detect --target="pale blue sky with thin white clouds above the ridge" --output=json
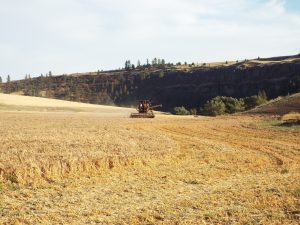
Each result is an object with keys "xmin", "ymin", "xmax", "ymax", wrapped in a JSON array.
[{"xmin": 0, "ymin": 0, "xmax": 300, "ymax": 80}]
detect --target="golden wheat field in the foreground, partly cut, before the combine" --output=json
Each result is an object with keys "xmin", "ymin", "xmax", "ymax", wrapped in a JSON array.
[{"xmin": 0, "ymin": 94, "xmax": 300, "ymax": 224}]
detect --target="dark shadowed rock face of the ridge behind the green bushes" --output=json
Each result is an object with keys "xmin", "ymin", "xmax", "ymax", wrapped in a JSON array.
[{"xmin": 138, "ymin": 63, "xmax": 300, "ymax": 109}]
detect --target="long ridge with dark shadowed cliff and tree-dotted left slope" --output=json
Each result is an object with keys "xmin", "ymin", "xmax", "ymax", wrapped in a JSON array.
[{"xmin": 0, "ymin": 55, "xmax": 300, "ymax": 111}]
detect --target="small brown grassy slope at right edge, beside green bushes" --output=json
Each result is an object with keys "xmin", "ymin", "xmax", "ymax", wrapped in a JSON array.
[{"xmin": 247, "ymin": 93, "xmax": 300, "ymax": 115}]
